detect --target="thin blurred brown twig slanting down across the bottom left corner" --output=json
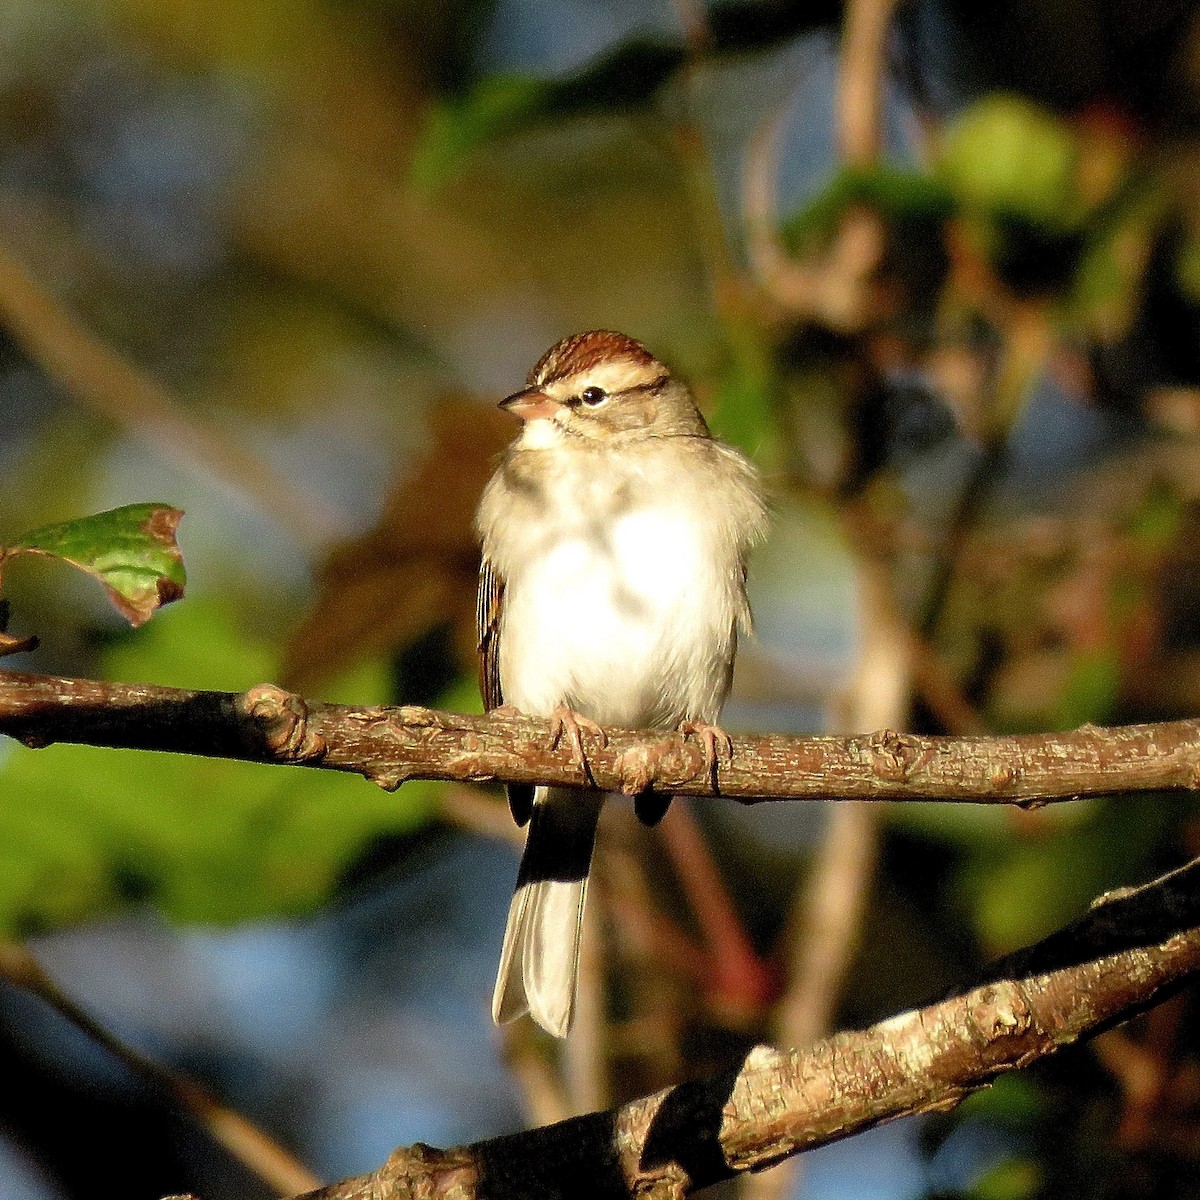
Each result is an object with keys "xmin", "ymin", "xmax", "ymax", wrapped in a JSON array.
[{"xmin": 0, "ymin": 941, "xmax": 320, "ymax": 1196}]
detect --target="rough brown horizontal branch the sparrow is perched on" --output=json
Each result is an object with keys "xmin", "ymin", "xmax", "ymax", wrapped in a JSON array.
[{"xmin": 0, "ymin": 672, "xmax": 1200, "ymax": 806}]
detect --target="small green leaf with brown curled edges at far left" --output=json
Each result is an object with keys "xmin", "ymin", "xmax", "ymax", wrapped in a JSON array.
[{"xmin": 0, "ymin": 504, "xmax": 187, "ymax": 625}]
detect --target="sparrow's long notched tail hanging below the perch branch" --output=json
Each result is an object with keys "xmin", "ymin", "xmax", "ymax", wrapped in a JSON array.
[{"xmin": 492, "ymin": 787, "xmax": 604, "ymax": 1038}]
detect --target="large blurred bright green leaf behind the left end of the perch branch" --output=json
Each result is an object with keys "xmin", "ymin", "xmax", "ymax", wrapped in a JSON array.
[{"xmin": 0, "ymin": 598, "xmax": 440, "ymax": 935}]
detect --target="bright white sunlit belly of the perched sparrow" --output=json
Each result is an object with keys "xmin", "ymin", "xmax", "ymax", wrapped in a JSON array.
[{"xmin": 500, "ymin": 510, "xmax": 733, "ymax": 727}]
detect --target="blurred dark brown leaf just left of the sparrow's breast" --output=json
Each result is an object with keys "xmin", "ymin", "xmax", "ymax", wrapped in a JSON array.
[{"xmin": 283, "ymin": 400, "xmax": 516, "ymax": 692}]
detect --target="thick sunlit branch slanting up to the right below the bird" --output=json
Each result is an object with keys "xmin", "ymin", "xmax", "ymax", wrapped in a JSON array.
[{"xmin": 295, "ymin": 860, "xmax": 1200, "ymax": 1200}]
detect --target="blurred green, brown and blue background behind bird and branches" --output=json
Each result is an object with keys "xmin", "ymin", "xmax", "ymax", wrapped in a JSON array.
[{"xmin": 0, "ymin": 0, "xmax": 1200, "ymax": 1200}]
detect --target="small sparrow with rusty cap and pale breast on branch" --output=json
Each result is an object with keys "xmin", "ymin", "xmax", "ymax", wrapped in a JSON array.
[{"xmin": 476, "ymin": 330, "xmax": 767, "ymax": 1037}]
